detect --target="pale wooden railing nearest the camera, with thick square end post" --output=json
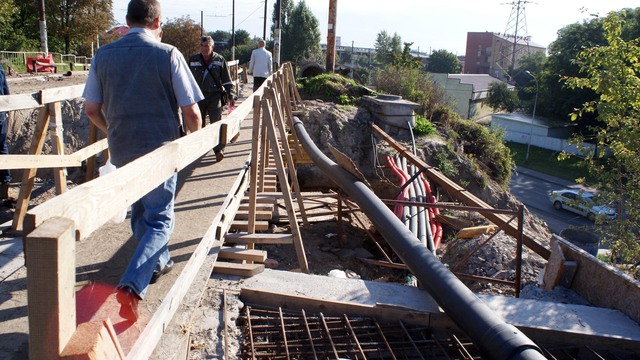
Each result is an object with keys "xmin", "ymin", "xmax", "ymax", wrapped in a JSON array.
[{"xmin": 18, "ymin": 64, "xmax": 295, "ymax": 359}]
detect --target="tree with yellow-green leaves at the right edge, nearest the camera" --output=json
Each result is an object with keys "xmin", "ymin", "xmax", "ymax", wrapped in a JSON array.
[{"xmin": 563, "ymin": 13, "xmax": 640, "ymax": 274}]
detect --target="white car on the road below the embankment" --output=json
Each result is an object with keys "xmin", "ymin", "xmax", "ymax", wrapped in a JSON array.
[{"xmin": 549, "ymin": 189, "xmax": 618, "ymax": 221}]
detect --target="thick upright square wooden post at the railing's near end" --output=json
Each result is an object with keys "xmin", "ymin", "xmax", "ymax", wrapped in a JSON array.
[{"xmin": 25, "ymin": 217, "xmax": 76, "ymax": 359}]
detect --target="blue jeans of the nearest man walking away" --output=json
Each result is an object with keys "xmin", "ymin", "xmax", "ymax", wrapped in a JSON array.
[{"xmin": 118, "ymin": 174, "xmax": 178, "ymax": 298}]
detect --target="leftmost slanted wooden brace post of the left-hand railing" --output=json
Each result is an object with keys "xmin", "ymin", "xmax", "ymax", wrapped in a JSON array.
[{"xmin": 11, "ymin": 106, "xmax": 49, "ymax": 232}]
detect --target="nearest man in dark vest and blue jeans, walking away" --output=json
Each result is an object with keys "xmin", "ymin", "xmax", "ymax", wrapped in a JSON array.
[{"xmin": 83, "ymin": 0, "xmax": 204, "ymax": 321}]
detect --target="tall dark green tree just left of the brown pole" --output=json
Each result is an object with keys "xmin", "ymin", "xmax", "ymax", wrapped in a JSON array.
[{"xmin": 274, "ymin": 0, "xmax": 322, "ymax": 62}]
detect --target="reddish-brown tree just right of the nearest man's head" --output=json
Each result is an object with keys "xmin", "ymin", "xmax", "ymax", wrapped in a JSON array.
[{"xmin": 162, "ymin": 15, "xmax": 200, "ymax": 59}]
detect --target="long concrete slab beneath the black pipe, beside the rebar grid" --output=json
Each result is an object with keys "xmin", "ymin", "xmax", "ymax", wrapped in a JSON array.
[{"xmin": 232, "ymin": 269, "xmax": 640, "ymax": 351}]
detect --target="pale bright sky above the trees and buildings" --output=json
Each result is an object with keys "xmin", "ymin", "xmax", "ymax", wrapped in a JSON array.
[{"xmin": 113, "ymin": 0, "xmax": 640, "ymax": 55}]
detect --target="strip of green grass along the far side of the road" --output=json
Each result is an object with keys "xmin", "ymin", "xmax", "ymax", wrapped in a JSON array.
[{"xmin": 505, "ymin": 142, "xmax": 592, "ymax": 183}]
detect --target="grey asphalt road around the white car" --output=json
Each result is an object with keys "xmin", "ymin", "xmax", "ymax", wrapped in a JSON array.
[{"xmin": 510, "ymin": 167, "xmax": 593, "ymax": 234}]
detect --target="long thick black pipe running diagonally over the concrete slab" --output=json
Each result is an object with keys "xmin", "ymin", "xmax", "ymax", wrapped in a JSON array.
[{"xmin": 293, "ymin": 118, "xmax": 546, "ymax": 360}]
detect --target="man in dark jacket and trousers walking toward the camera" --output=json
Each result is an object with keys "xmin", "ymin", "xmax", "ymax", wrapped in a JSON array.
[{"xmin": 189, "ymin": 36, "xmax": 235, "ymax": 161}]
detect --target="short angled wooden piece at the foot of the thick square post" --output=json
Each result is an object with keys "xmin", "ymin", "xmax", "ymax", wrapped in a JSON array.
[{"xmin": 60, "ymin": 319, "xmax": 125, "ymax": 360}]
